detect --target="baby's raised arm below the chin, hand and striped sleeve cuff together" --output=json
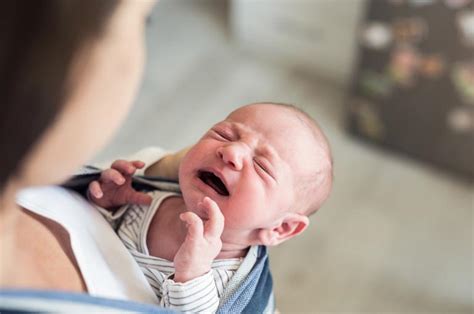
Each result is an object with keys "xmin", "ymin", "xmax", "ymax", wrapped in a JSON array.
[{"xmin": 162, "ymin": 197, "xmax": 224, "ymax": 312}]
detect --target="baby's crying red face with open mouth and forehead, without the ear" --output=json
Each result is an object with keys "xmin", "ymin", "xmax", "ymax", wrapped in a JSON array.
[{"xmin": 179, "ymin": 104, "xmax": 314, "ymax": 239}]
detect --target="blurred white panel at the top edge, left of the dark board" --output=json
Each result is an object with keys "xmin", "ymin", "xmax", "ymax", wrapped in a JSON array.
[{"xmin": 231, "ymin": 0, "xmax": 366, "ymax": 85}]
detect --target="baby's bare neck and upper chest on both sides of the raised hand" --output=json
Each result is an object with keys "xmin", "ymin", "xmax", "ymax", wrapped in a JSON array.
[{"xmin": 147, "ymin": 197, "xmax": 249, "ymax": 261}]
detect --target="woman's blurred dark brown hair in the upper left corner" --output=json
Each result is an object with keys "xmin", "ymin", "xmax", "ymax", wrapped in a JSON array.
[{"xmin": 0, "ymin": 0, "xmax": 119, "ymax": 192}]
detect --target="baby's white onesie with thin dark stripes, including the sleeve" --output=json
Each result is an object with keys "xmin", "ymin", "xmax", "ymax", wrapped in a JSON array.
[{"xmin": 99, "ymin": 191, "xmax": 242, "ymax": 313}]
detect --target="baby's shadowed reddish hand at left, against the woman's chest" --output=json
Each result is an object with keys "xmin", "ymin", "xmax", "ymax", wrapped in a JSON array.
[{"xmin": 89, "ymin": 160, "xmax": 151, "ymax": 209}]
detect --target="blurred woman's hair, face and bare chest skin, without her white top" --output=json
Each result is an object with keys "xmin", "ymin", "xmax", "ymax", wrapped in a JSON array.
[{"xmin": 0, "ymin": 0, "xmax": 154, "ymax": 292}]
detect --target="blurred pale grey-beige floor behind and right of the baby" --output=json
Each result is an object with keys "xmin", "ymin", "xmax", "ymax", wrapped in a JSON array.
[{"xmin": 96, "ymin": 0, "xmax": 474, "ymax": 313}]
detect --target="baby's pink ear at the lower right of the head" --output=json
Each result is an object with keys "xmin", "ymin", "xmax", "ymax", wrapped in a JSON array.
[{"xmin": 258, "ymin": 213, "xmax": 309, "ymax": 246}]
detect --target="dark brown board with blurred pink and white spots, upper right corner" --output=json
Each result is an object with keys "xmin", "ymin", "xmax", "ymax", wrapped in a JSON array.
[{"xmin": 347, "ymin": 0, "xmax": 474, "ymax": 180}]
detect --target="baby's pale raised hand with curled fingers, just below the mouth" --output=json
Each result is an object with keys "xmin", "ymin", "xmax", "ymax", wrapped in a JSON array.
[{"xmin": 174, "ymin": 197, "xmax": 224, "ymax": 282}]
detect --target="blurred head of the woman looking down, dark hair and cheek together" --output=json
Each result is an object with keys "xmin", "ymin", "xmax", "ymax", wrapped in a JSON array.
[{"xmin": 0, "ymin": 0, "xmax": 153, "ymax": 190}]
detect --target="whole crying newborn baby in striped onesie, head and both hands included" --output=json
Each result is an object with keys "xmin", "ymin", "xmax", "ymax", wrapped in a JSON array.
[{"xmin": 89, "ymin": 103, "xmax": 332, "ymax": 312}]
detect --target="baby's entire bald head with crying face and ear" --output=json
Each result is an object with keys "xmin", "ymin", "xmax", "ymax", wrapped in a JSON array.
[{"xmin": 179, "ymin": 103, "xmax": 332, "ymax": 245}]
